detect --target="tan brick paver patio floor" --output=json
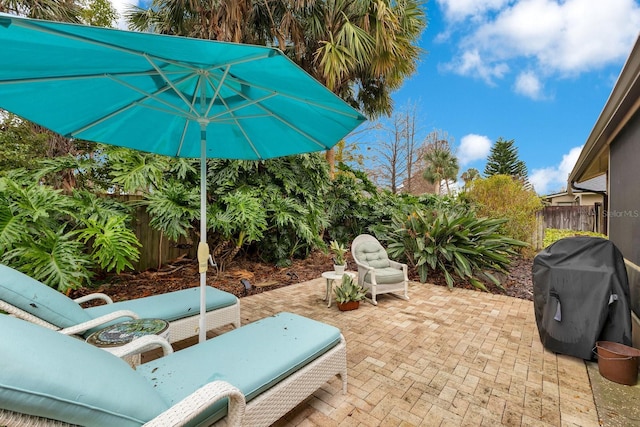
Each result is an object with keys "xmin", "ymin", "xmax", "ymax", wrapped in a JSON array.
[{"xmin": 169, "ymin": 279, "xmax": 599, "ymax": 427}]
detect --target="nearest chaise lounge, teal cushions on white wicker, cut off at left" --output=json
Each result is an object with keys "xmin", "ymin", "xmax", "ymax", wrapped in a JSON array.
[{"xmin": 0, "ymin": 313, "xmax": 347, "ymax": 427}]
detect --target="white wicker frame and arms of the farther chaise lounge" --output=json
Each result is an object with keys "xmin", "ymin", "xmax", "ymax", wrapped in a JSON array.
[{"xmin": 0, "ymin": 293, "xmax": 240, "ymax": 343}]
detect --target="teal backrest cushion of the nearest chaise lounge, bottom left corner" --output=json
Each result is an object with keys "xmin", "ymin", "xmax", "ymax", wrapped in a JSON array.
[{"xmin": 0, "ymin": 315, "xmax": 169, "ymax": 426}]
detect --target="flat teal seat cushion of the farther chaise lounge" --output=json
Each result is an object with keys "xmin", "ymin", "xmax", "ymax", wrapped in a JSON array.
[{"xmin": 85, "ymin": 286, "xmax": 238, "ymax": 334}]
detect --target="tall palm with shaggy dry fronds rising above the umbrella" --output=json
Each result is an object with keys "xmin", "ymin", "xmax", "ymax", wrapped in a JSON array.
[{"xmin": 127, "ymin": 0, "xmax": 426, "ymax": 176}]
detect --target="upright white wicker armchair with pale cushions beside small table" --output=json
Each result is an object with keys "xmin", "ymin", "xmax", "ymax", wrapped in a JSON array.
[{"xmin": 351, "ymin": 234, "xmax": 409, "ymax": 305}]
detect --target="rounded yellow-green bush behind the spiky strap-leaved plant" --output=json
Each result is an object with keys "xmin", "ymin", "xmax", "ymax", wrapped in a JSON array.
[{"xmin": 467, "ymin": 175, "xmax": 542, "ymax": 247}]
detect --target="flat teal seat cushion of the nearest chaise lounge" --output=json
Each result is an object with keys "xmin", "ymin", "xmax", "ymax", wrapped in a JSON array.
[{"xmin": 136, "ymin": 313, "xmax": 340, "ymax": 422}]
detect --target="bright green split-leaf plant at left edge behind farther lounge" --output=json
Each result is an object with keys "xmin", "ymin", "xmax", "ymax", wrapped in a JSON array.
[{"xmin": 0, "ymin": 177, "xmax": 140, "ymax": 292}]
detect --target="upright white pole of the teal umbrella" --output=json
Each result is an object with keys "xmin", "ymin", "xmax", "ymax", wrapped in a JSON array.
[{"xmin": 198, "ymin": 123, "xmax": 209, "ymax": 342}]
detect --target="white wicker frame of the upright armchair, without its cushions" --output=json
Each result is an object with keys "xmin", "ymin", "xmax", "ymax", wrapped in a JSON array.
[{"xmin": 351, "ymin": 234, "xmax": 409, "ymax": 305}]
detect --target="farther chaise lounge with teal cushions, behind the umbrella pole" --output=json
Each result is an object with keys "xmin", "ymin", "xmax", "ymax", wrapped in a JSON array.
[{"xmin": 0, "ymin": 264, "xmax": 240, "ymax": 343}]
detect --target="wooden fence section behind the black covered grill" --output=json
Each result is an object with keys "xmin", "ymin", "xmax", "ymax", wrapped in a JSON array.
[{"xmin": 531, "ymin": 204, "xmax": 604, "ymax": 250}]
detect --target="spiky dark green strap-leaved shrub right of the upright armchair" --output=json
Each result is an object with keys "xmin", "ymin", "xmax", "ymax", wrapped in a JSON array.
[{"xmin": 387, "ymin": 208, "xmax": 526, "ymax": 290}]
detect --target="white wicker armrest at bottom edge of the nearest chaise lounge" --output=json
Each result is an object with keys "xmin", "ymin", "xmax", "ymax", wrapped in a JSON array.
[{"xmin": 144, "ymin": 381, "xmax": 246, "ymax": 427}]
